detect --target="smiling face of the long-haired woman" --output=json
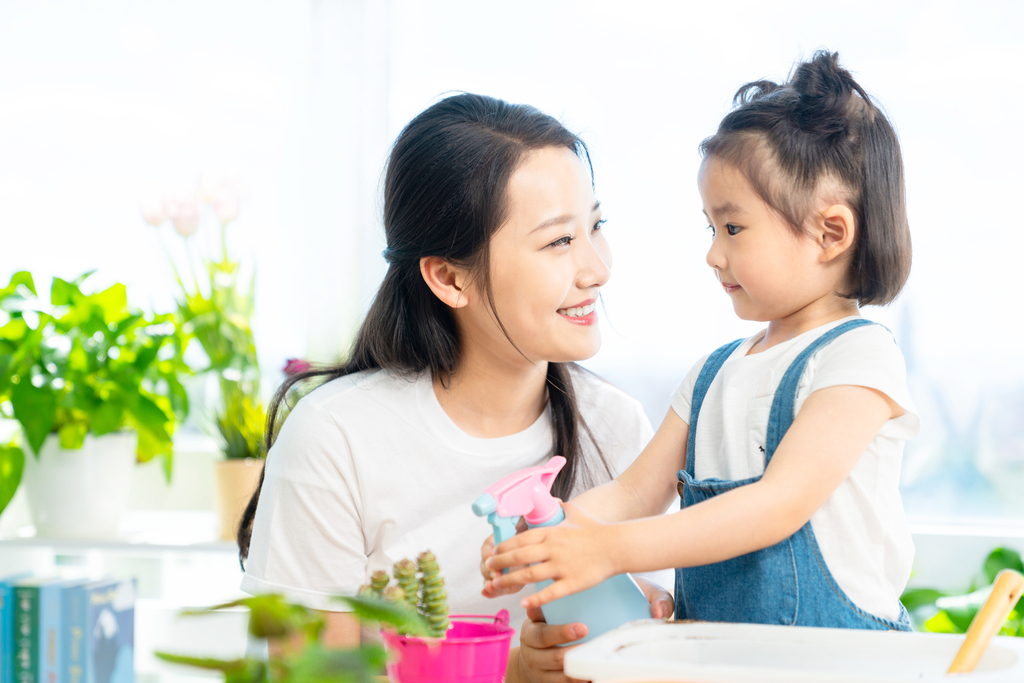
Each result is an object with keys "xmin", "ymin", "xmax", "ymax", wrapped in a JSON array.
[{"xmin": 460, "ymin": 147, "xmax": 611, "ymax": 362}]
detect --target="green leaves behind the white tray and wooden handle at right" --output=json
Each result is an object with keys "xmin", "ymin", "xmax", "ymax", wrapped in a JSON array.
[{"xmin": 900, "ymin": 548, "xmax": 1024, "ymax": 637}]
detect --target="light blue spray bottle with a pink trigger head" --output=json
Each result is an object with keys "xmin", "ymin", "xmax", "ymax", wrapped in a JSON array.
[{"xmin": 473, "ymin": 456, "xmax": 650, "ymax": 642}]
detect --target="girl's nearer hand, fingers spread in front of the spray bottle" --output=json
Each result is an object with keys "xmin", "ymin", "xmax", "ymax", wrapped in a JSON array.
[{"xmin": 485, "ymin": 503, "xmax": 621, "ymax": 609}]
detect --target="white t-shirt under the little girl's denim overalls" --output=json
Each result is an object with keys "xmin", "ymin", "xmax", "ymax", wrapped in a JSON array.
[{"xmin": 672, "ymin": 316, "xmax": 921, "ymax": 620}]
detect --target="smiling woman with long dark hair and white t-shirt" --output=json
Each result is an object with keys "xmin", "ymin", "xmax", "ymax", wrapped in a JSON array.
[{"xmin": 239, "ymin": 94, "xmax": 671, "ymax": 680}]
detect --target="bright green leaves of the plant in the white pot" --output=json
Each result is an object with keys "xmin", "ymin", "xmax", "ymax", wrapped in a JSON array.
[{"xmin": 0, "ymin": 271, "xmax": 190, "ymax": 493}]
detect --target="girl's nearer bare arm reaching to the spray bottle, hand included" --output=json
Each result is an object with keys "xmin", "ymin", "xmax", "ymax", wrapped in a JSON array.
[{"xmin": 488, "ymin": 386, "xmax": 903, "ymax": 607}]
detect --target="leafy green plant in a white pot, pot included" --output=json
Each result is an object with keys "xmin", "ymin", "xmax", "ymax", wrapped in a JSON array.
[{"xmin": 0, "ymin": 271, "xmax": 189, "ymax": 538}]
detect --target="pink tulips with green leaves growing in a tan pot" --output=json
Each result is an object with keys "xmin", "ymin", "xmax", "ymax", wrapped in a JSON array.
[{"xmin": 142, "ymin": 180, "xmax": 266, "ymax": 540}]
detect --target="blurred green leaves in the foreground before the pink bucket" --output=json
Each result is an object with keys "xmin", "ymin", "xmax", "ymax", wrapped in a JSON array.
[{"xmin": 156, "ymin": 595, "xmax": 429, "ymax": 683}]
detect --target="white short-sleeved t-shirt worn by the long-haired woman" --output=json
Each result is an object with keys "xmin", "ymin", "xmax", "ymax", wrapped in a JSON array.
[{"xmin": 242, "ymin": 370, "xmax": 655, "ymax": 643}]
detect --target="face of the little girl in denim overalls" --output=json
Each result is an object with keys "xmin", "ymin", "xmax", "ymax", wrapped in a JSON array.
[{"xmin": 697, "ymin": 157, "xmax": 836, "ymax": 321}]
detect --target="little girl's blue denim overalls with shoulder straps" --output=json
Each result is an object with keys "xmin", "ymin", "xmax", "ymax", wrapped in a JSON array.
[{"xmin": 676, "ymin": 319, "xmax": 910, "ymax": 631}]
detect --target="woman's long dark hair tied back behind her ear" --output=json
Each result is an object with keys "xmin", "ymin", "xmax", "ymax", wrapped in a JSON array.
[{"xmin": 238, "ymin": 93, "xmax": 611, "ymax": 567}]
